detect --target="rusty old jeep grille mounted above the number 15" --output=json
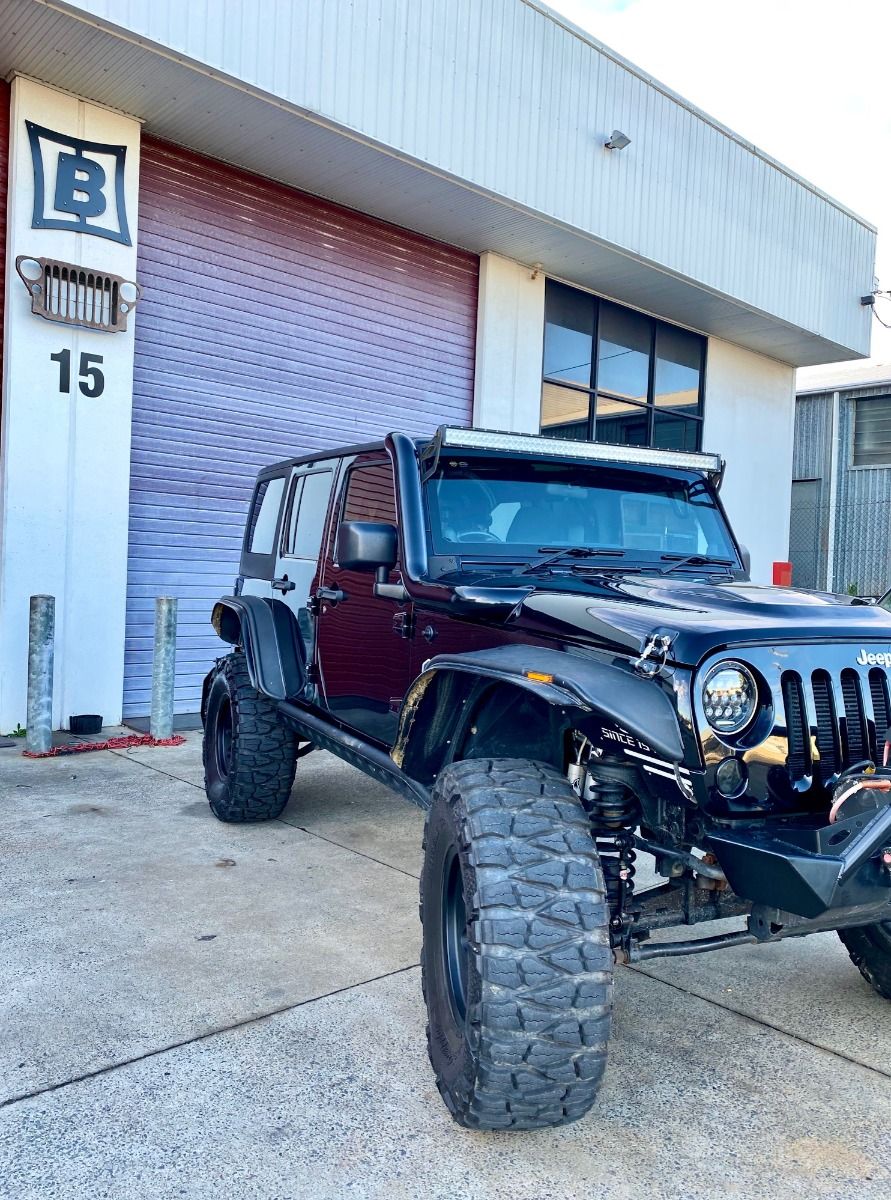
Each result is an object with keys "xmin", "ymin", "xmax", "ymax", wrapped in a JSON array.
[{"xmin": 16, "ymin": 254, "xmax": 140, "ymax": 334}]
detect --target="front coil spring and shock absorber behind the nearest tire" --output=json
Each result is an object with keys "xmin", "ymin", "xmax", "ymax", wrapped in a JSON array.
[{"xmin": 582, "ymin": 762, "xmax": 640, "ymax": 944}]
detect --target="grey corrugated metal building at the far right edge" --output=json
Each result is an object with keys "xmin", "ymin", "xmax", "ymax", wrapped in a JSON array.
[{"xmin": 789, "ymin": 362, "xmax": 891, "ymax": 596}]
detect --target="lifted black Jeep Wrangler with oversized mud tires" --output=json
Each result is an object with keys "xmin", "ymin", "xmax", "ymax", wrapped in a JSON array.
[{"xmin": 203, "ymin": 428, "xmax": 891, "ymax": 1129}]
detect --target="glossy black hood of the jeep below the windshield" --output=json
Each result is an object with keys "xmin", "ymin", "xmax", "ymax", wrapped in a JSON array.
[{"xmin": 508, "ymin": 575, "xmax": 891, "ymax": 666}]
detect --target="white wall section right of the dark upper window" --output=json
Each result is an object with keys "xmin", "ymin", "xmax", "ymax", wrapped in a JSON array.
[{"xmin": 702, "ymin": 337, "xmax": 795, "ymax": 583}]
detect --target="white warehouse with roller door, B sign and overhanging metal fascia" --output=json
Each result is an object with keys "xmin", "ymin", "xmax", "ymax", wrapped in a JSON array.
[{"xmin": 0, "ymin": 0, "xmax": 874, "ymax": 730}]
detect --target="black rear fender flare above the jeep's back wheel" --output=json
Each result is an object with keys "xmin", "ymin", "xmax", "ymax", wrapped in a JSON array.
[{"xmin": 210, "ymin": 596, "xmax": 306, "ymax": 700}]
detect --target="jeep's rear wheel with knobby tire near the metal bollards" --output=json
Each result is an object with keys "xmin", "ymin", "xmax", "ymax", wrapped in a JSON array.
[{"xmin": 203, "ymin": 650, "xmax": 297, "ymax": 823}]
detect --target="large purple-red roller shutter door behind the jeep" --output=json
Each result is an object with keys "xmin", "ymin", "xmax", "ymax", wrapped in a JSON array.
[{"xmin": 124, "ymin": 138, "xmax": 478, "ymax": 716}]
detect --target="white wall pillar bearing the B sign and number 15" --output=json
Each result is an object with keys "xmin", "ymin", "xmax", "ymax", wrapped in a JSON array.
[{"xmin": 0, "ymin": 77, "xmax": 139, "ymax": 732}]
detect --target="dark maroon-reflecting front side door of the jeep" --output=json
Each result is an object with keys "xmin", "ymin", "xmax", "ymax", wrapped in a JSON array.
[{"xmin": 316, "ymin": 451, "xmax": 412, "ymax": 745}]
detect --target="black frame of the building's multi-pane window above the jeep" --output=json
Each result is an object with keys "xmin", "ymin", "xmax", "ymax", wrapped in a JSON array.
[{"xmin": 539, "ymin": 277, "xmax": 708, "ymax": 450}]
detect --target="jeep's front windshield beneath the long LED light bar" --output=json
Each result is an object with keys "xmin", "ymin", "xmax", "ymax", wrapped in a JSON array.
[{"xmin": 426, "ymin": 455, "xmax": 738, "ymax": 568}]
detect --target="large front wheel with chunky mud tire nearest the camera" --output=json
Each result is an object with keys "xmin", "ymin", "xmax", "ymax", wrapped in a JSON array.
[{"xmin": 420, "ymin": 760, "xmax": 612, "ymax": 1129}]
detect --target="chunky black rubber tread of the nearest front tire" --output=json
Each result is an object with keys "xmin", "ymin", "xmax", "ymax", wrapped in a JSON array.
[{"xmin": 421, "ymin": 760, "xmax": 612, "ymax": 1129}]
